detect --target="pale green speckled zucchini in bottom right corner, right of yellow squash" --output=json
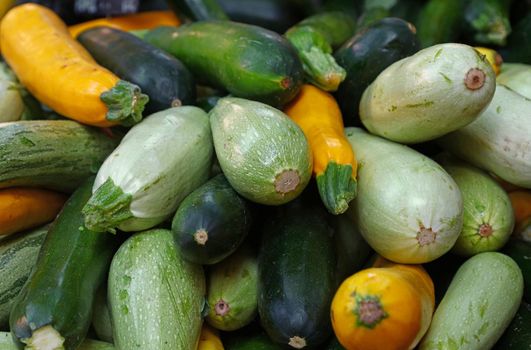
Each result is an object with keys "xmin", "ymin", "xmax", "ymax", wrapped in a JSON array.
[{"xmin": 420, "ymin": 252, "xmax": 524, "ymax": 350}]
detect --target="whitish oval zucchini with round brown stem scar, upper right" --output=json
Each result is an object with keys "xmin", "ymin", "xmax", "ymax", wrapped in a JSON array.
[{"xmin": 360, "ymin": 43, "xmax": 496, "ymax": 143}]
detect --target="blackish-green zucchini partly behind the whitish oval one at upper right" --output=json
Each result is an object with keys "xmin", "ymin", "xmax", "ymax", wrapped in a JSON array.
[{"xmin": 334, "ymin": 18, "xmax": 420, "ymax": 126}]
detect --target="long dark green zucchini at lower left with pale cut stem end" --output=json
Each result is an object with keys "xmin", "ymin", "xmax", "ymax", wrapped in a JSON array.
[{"xmin": 9, "ymin": 178, "xmax": 119, "ymax": 350}]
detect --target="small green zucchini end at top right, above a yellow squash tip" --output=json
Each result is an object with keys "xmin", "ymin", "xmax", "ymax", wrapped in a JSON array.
[{"xmin": 464, "ymin": 0, "xmax": 512, "ymax": 46}]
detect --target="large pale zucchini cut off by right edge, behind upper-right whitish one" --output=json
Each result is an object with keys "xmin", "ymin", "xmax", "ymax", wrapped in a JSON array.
[{"xmin": 438, "ymin": 85, "xmax": 531, "ymax": 188}]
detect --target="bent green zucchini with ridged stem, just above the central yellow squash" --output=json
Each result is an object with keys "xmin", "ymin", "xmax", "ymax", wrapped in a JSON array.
[{"xmin": 285, "ymin": 12, "xmax": 356, "ymax": 91}]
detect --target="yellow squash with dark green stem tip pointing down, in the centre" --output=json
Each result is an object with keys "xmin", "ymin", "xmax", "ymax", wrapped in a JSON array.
[{"xmin": 284, "ymin": 85, "xmax": 357, "ymax": 214}]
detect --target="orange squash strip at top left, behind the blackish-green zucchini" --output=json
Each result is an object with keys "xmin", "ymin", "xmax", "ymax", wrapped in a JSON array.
[{"xmin": 68, "ymin": 11, "xmax": 180, "ymax": 38}]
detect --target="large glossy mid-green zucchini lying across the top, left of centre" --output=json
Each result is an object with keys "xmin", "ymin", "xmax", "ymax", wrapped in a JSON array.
[{"xmin": 144, "ymin": 21, "xmax": 303, "ymax": 106}]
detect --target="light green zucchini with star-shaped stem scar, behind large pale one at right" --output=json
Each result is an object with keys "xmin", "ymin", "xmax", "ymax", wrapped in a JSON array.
[{"xmin": 442, "ymin": 160, "xmax": 514, "ymax": 256}]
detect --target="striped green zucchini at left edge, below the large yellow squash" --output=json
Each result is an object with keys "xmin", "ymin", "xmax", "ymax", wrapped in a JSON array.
[{"xmin": 0, "ymin": 120, "xmax": 119, "ymax": 192}]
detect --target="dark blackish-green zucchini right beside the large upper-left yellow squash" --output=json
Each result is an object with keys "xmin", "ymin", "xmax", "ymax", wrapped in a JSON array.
[{"xmin": 77, "ymin": 27, "xmax": 195, "ymax": 114}]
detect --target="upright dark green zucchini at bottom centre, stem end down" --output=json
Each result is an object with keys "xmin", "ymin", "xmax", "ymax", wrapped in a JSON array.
[{"xmin": 258, "ymin": 199, "xmax": 336, "ymax": 349}]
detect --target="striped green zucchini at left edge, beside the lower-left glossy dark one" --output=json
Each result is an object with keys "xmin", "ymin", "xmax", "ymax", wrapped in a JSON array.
[{"xmin": 0, "ymin": 225, "xmax": 48, "ymax": 330}]
